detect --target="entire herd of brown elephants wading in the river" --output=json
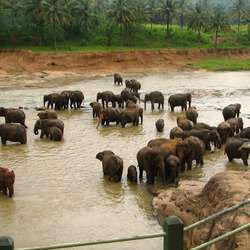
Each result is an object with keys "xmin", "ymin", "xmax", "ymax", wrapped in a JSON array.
[{"xmin": 0, "ymin": 74, "xmax": 250, "ymax": 197}]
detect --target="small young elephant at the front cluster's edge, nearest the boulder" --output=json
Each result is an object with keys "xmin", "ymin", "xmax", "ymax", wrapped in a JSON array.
[{"xmin": 165, "ymin": 155, "xmax": 181, "ymax": 185}]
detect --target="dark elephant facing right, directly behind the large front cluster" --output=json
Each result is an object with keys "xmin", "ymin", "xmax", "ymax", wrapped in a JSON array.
[{"xmin": 187, "ymin": 129, "xmax": 222, "ymax": 151}]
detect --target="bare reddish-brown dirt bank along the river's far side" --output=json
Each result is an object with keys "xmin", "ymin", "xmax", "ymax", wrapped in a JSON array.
[{"xmin": 0, "ymin": 49, "xmax": 250, "ymax": 89}]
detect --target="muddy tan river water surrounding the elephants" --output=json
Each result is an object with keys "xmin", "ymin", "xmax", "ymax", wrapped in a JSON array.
[{"xmin": 0, "ymin": 71, "xmax": 250, "ymax": 250}]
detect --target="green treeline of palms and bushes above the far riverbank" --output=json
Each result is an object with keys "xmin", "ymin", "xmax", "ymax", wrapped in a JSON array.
[{"xmin": 0, "ymin": 0, "xmax": 250, "ymax": 50}]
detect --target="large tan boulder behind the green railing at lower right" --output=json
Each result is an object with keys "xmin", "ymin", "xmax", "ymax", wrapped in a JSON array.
[{"xmin": 153, "ymin": 171, "xmax": 250, "ymax": 250}]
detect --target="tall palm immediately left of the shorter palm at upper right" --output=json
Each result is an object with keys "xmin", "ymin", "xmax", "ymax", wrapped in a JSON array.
[{"xmin": 187, "ymin": 2, "xmax": 207, "ymax": 48}]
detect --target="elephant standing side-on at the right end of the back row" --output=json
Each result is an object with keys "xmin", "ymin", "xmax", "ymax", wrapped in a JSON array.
[{"xmin": 168, "ymin": 93, "xmax": 192, "ymax": 112}]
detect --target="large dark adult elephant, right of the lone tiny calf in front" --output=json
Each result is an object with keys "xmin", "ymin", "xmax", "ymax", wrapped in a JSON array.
[{"xmin": 136, "ymin": 147, "xmax": 166, "ymax": 185}]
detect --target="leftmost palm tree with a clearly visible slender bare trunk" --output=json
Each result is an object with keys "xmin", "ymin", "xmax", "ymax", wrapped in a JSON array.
[{"xmin": 42, "ymin": 0, "xmax": 71, "ymax": 50}]
